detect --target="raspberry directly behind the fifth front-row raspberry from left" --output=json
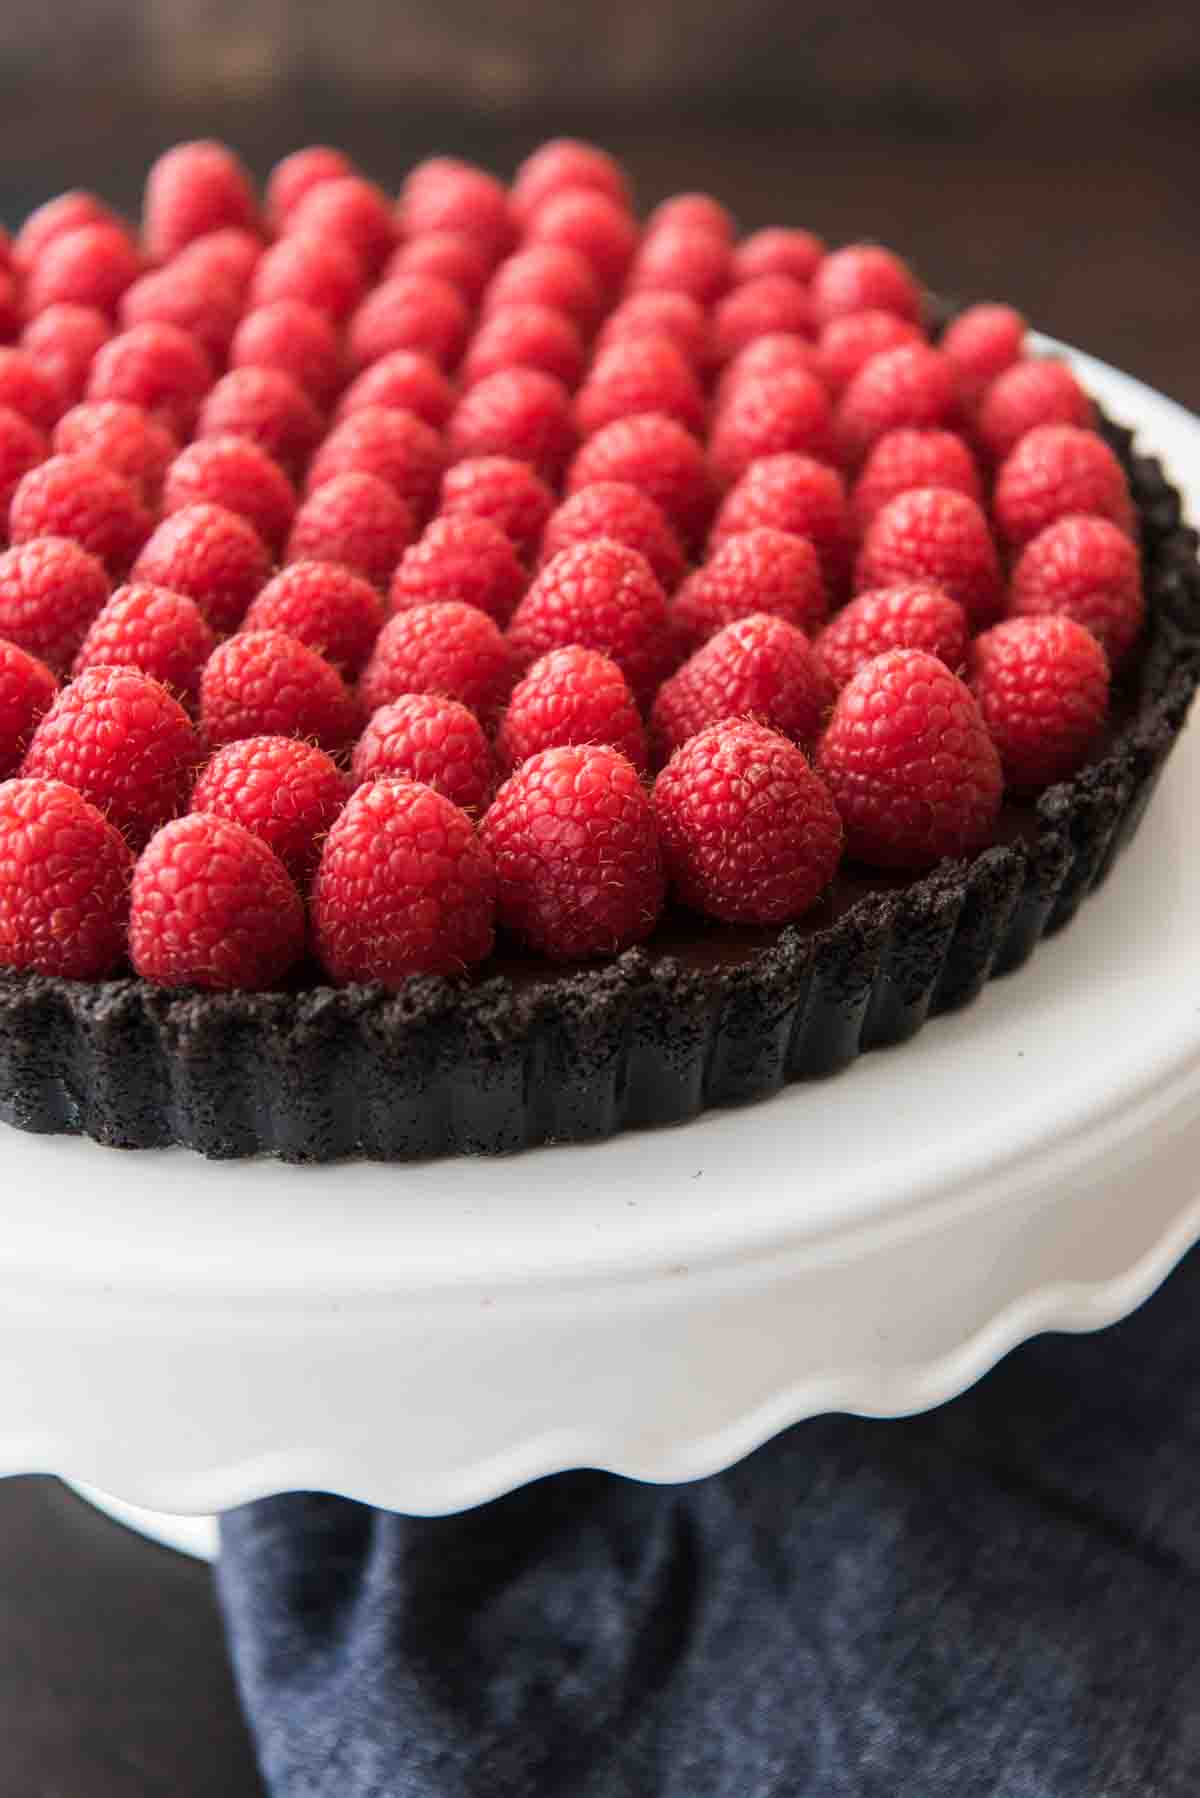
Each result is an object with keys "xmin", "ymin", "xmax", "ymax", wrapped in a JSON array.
[{"xmin": 651, "ymin": 611, "xmax": 829, "ymax": 761}]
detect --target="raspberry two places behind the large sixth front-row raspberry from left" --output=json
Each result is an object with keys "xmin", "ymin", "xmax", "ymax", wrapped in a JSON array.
[{"xmin": 855, "ymin": 487, "xmax": 1002, "ymax": 631}]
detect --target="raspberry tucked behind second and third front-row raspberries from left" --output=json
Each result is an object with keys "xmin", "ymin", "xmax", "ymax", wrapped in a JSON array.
[{"xmin": 191, "ymin": 737, "xmax": 349, "ymax": 890}]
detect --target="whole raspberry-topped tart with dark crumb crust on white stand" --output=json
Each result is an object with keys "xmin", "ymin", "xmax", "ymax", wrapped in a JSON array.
[{"xmin": 0, "ymin": 140, "xmax": 1200, "ymax": 1162}]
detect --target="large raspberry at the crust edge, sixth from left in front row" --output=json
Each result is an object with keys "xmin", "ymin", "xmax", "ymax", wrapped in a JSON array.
[{"xmin": 817, "ymin": 649, "xmax": 1004, "ymax": 872}]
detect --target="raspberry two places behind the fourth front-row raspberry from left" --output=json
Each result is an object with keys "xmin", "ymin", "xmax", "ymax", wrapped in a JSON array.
[{"xmin": 509, "ymin": 538, "xmax": 673, "ymax": 703}]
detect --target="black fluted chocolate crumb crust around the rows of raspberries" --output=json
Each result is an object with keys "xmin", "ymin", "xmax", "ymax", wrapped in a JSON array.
[{"xmin": 0, "ymin": 404, "xmax": 1200, "ymax": 1162}]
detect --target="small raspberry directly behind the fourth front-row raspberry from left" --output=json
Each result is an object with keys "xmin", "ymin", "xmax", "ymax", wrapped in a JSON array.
[{"xmin": 497, "ymin": 644, "xmax": 646, "ymax": 773}]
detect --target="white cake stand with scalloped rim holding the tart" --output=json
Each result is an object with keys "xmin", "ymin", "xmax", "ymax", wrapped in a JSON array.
[{"xmin": 0, "ymin": 347, "xmax": 1200, "ymax": 1550}]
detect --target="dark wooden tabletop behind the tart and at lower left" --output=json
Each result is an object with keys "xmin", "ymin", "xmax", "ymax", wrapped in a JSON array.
[{"xmin": 0, "ymin": 102, "xmax": 1200, "ymax": 1798}]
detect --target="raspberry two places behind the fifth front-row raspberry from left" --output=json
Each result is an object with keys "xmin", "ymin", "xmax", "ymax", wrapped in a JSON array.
[{"xmin": 671, "ymin": 529, "xmax": 829, "ymax": 654}]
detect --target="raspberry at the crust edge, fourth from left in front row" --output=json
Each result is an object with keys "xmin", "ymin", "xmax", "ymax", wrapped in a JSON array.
[{"xmin": 480, "ymin": 744, "xmax": 666, "ymax": 960}]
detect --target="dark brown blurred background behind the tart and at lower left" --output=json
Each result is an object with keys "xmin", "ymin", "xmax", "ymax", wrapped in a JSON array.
[{"xmin": 0, "ymin": 0, "xmax": 1200, "ymax": 1798}]
